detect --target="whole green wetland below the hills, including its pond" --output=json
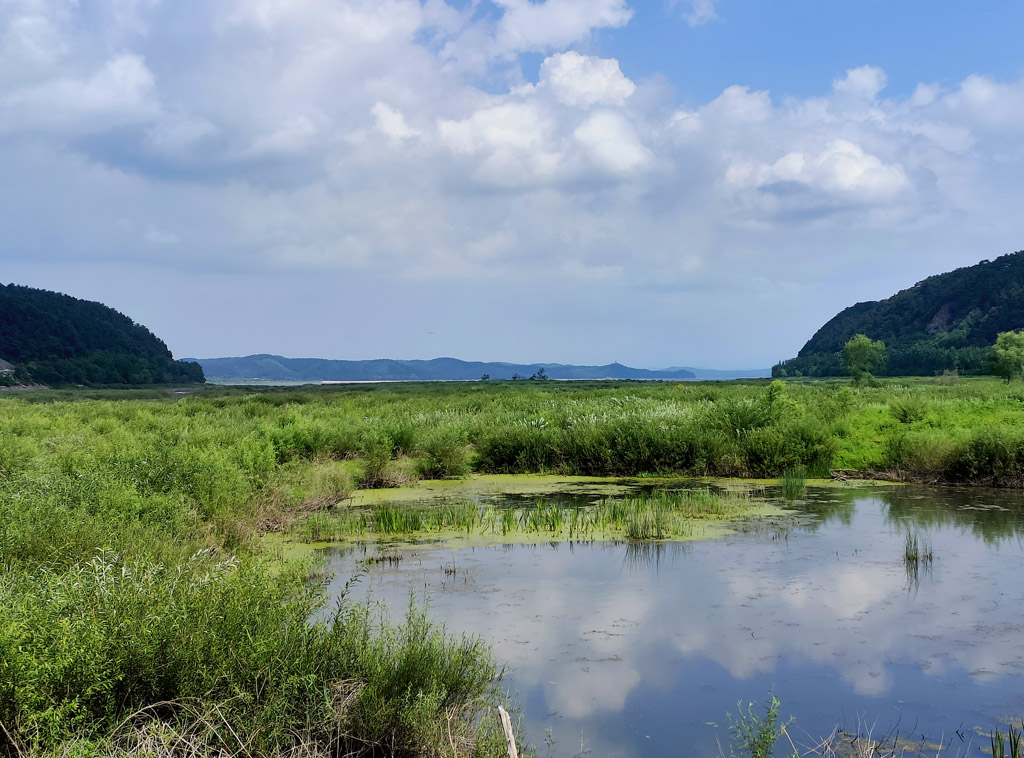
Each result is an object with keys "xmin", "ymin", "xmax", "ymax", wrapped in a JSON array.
[{"xmin": 6, "ymin": 377, "xmax": 1024, "ymax": 758}]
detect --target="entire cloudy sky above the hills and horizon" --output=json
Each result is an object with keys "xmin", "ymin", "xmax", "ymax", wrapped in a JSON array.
[{"xmin": 0, "ymin": 0, "xmax": 1024, "ymax": 368}]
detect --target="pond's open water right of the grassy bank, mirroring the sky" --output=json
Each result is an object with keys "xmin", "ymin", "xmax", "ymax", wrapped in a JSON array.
[{"xmin": 315, "ymin": 487, "xmax": 1024, "ymax": 758}]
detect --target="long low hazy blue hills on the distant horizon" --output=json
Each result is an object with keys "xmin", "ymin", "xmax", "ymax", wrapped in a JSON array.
[{"xmin": 199, "ymin": 355, "xmax": 694, "ymax": 382}]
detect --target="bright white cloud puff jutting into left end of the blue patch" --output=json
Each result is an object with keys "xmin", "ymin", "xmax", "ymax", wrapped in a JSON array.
[{"xmin": 540, "ymin": 50, "xmax": 636, "ymax": 108}]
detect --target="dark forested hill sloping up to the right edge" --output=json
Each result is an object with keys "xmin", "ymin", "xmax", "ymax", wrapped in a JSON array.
[{"xmin": 772, "ymin": 252, "xmax": 1024, "ymax": 377}]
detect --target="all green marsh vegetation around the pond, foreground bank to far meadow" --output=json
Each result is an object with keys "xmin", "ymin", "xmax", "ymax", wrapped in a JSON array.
[{"xmin": 6, "ymin": 380, "xmax": 1024, "ymax": 756}]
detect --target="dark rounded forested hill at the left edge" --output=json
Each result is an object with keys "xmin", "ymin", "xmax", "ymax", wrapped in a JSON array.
[{"xmin": 0, "ymin": 284, "xmax": 205, "ymax": 385}]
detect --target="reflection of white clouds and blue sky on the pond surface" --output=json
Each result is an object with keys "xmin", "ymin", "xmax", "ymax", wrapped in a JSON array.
[{"xmin": 323, "ymin": 487, "xmax": 1024, "ymax": 754}]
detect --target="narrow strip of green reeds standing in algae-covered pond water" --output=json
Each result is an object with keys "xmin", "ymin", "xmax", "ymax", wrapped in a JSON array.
[{"xmin": 297, "ymin": 490, "xmax": 757, "ymax": 542}]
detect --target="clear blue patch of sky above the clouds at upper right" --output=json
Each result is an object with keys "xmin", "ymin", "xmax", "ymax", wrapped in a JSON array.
[{"xmin": 601, "ymin": 0, "xmax": 1024, "ymax": 104}]
